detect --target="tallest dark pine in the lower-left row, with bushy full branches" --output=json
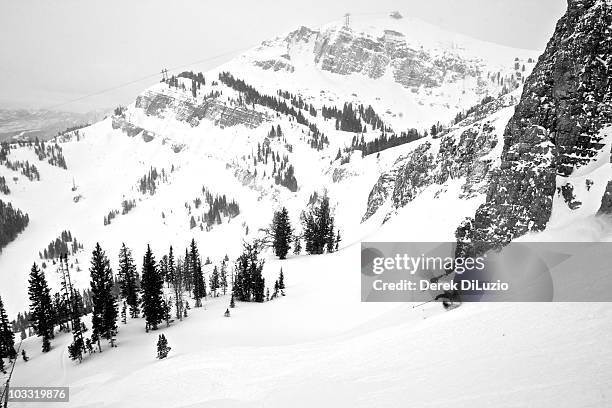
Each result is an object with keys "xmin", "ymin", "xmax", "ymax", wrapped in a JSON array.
[{"xmin": 89, "ymin": 243, "xmax": 118, "ymax": 352}]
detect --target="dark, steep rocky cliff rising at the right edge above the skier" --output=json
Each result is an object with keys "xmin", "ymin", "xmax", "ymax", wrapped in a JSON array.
[{"xmin": 456, "ymin": 0, "xmax": 612, "ymax": 252}]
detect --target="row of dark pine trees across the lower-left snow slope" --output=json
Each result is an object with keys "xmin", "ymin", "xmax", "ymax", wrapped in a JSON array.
[{"xmin": 22, "ymin": 239, "xmax": 285, "ymax": 361}]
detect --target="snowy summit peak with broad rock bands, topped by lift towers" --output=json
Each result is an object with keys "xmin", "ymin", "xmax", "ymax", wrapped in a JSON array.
[{"xmin": 220, "ymin": 12, "xmax": 538, "ymax": 129}]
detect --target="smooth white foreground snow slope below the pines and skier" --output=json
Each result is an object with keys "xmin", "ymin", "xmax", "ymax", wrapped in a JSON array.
[{"xmin": 5, "ymin": 253, "xmax": 612, "ymax": 408}]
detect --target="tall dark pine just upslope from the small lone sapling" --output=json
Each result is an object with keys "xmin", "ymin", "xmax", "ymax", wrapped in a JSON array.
[{"xmin": 141, "ymin": 245, "xmax": 164, "ymax": 331}]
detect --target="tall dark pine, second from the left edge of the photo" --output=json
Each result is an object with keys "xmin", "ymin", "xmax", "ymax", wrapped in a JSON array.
[{"xmin": 28, "ymin": 264, "xmax": 55, "ymax": 353}]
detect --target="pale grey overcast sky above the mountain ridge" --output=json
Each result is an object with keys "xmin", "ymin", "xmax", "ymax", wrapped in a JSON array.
[{"xmin": 0, "ymin": 0, "xmax": 566, "ymax": 111}]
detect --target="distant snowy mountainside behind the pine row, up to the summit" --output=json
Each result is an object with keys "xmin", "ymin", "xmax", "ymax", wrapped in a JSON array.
[{"xmin": 0, "ymin": 11, "xmax": 535, "ymax": 313}]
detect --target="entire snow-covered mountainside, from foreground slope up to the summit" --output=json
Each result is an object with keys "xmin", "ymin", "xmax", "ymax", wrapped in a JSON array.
[{"xmin": 0, "ymin": 6, "xmax": 612, "ymax": 407}]
